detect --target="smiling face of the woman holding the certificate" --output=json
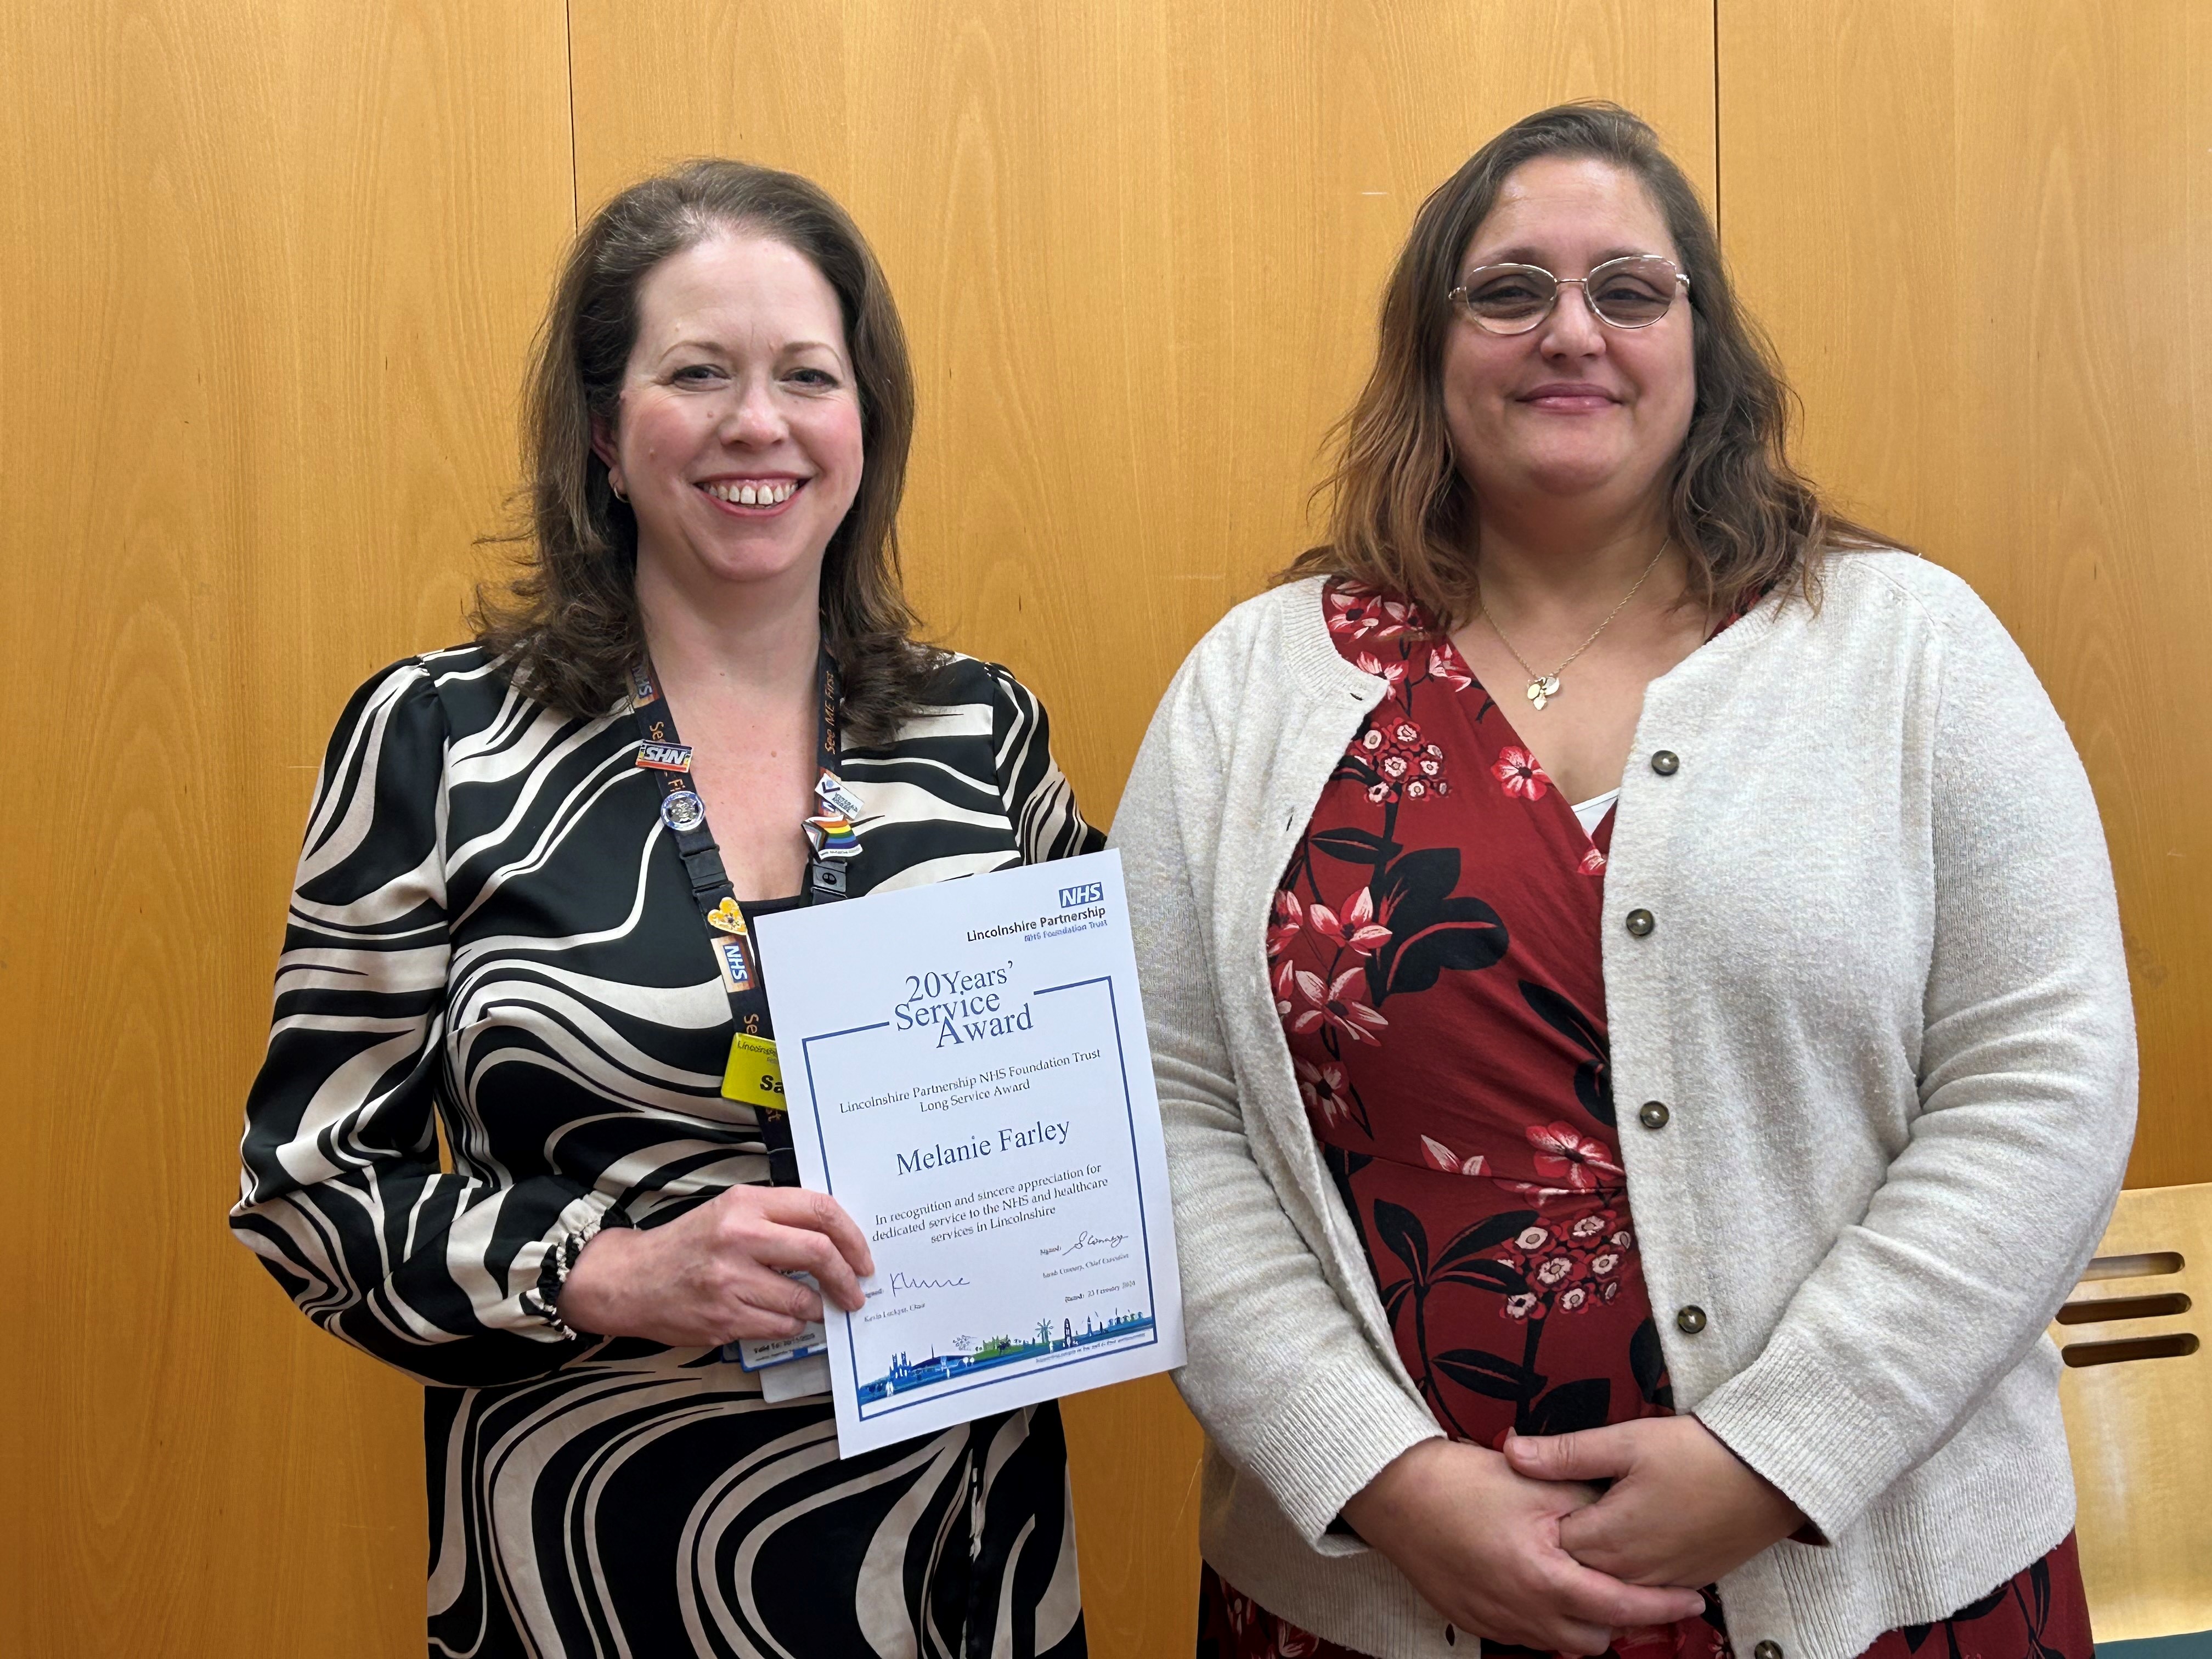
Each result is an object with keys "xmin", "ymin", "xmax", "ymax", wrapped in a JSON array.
[{"xmin": 593, "ymin": 230, "xmax": 860, "ymax": 606}]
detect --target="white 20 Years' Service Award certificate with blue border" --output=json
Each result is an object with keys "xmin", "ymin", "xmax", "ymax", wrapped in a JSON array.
[{"xmin": 754, "ymin": 851, "xmax": 1183, "ymax": 1458}]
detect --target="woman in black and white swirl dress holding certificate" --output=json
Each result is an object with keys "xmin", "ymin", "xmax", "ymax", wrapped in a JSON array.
[{"xmin": 232, "ymin": 161, "xmax": 1099, "ymax": 1659}]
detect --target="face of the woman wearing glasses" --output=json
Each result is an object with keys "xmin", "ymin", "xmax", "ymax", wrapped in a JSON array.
[{"xmin": 1444, "ymin": 155, "xmax": 1697, "ymax": 533}]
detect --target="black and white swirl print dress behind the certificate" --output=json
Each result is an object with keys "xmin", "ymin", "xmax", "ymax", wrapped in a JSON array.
[{"xmin": 232, "ymin": 646, "xmax": 1104, "ymax": 1659}]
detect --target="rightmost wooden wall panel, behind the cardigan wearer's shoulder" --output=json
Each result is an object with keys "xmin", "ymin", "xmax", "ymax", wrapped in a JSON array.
[{"xmin": 1719, "ymin": 0, "xmax": 2212, "ymax": 1186}]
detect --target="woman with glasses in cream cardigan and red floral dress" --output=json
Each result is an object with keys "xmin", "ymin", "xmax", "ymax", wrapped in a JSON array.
[{"xmin": 1115, "ymin": 106, "xmax": 2135, "ymax": 1659}]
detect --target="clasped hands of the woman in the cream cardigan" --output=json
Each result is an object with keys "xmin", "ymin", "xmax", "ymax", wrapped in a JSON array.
[{"xmin": 1345, "ymin": 1415, "xmax": 1805, "ymax": 1655}]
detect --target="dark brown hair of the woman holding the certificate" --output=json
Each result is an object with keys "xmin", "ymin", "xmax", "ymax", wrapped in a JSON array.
[{"xmin": 469, "ymin": 159, "xmax": 940, "ymax": 739}]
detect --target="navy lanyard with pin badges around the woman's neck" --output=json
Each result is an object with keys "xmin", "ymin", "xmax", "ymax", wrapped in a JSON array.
[{"xmin": 630, "ymin": 650, "xmax": 860, "ymax": 1186}]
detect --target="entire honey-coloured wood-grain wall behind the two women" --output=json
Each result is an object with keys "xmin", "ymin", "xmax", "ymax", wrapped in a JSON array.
[{"xmin": 0, "ymin": 0, "xmax": 2212, "ymax": 1659}]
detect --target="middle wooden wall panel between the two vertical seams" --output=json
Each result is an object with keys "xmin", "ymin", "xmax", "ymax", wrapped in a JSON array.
[{"xmin": 571, "ymin": 0, "xmax": 1714, "ymax": 1657}]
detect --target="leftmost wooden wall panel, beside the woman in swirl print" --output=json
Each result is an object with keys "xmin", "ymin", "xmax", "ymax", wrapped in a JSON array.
[{"xmin": 0, "ymin": 0, "xmax": 573, "ymax": 1659}]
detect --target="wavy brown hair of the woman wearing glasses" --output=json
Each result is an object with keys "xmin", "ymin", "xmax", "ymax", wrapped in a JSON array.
[{"xmin": 1281, "ymin": 101, "xmax": 1895, "ymax": 622}]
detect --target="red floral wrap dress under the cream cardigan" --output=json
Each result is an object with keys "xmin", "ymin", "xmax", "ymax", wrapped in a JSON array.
[{"xmin": 1197, "ymin": 582, "xmax": 2090, "ymax": 1659}]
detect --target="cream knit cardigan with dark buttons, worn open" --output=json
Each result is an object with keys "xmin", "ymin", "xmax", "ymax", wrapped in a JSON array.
[{"xmin": 1113, "ymin": 553, "xmax": 2135, "ymax": 1659}]
